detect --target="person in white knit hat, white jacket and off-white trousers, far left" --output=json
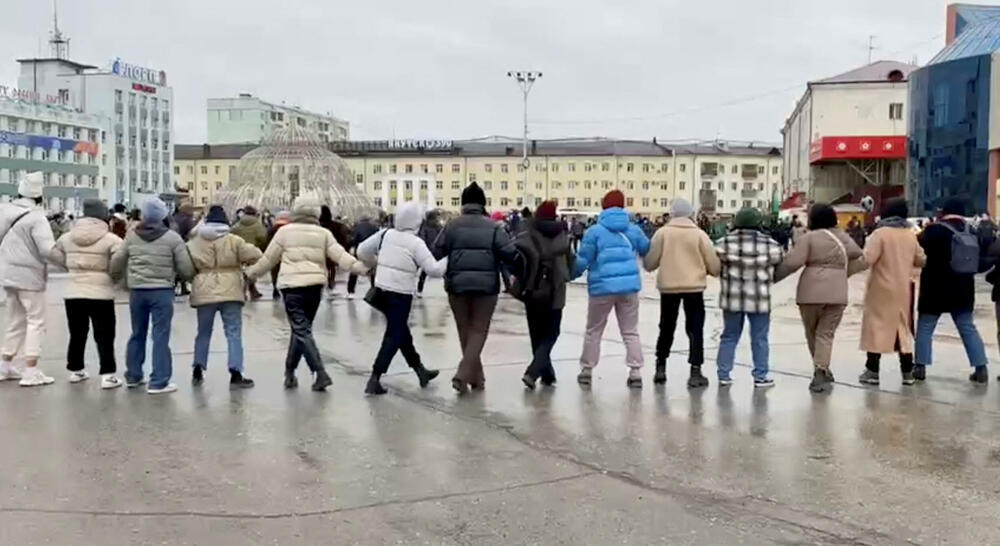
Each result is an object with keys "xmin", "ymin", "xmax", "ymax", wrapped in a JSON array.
[{"xmin": 0, "ymin": 172, "xmax": 55, "ymax": 387}]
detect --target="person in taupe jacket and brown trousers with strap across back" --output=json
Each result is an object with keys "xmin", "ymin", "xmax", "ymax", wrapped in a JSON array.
[{"xmin": 774, "ymin": 203, "xmax": 864, "ymax": 393}]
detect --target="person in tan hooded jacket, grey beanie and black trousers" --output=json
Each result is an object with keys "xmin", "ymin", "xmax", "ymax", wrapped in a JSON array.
[{"xmin": 643, "ymin": 197, "xmax": 722, "ymax": 388}]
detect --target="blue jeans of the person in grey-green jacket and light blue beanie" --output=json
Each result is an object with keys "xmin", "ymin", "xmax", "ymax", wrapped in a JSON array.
[{"xmin": 125, "ymin": 288, "xmax": 174, "ymax": 389}]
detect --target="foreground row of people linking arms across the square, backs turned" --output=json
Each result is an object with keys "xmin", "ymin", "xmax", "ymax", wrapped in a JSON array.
[{"xmin": 0, "ymin": 173, "xmax": 1000, "ymax": 395}]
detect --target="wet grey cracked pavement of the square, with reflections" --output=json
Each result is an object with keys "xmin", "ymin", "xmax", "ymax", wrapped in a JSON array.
[{"xmin": 0, "ymin": 277, "xmax": 1000, "ymax": 545}]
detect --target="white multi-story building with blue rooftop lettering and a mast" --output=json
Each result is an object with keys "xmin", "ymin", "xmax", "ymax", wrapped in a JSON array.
[{"xmin": 18, "ymin": 57, "xmax": 173, "ymax": 205}]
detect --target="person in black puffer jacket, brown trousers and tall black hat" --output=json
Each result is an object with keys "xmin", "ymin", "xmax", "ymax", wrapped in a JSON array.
[{"xmin": 434, "ymin": 182, "xmax": 517, "ymax": 394}]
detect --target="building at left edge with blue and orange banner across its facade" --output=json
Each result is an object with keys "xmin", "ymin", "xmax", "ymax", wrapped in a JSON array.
[{"xmin": 0, "ymin": 86, "xmax": 102, "ymax": 212}]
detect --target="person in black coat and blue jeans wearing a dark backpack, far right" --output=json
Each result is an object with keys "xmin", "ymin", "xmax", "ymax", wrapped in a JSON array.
[{"xmin": 913, "ymin": 198, "xmax": 989, "ymax": 384}]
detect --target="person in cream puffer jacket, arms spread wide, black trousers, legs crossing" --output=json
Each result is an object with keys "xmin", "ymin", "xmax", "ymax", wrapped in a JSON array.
[{"xmin": 246, "ymin": 196, "xmax": 368, "ymax": 391}]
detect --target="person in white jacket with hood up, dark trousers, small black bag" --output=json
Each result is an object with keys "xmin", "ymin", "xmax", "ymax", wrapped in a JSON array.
[{"xmin": 358, "ymin": 202, "xmax": 448, "ymax": 395}]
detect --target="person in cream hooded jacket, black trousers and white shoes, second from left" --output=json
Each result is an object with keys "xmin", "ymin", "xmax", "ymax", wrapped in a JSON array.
[{"xmin": 49, "ymin": 199, "xmax": 122, "ymax": 389}]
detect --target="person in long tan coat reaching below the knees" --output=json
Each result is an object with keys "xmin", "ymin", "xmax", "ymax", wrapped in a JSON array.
[{"xmin": 859, "ymin": 198, "xmax": 927, "ymax": 385}]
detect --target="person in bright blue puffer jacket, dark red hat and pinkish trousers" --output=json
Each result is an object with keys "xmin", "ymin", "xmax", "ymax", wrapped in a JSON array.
[{"xmin": 573, "ymin": 190, "xmax": 649, "ymax": 389}]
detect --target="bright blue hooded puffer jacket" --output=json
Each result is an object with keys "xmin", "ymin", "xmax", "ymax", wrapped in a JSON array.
[{"xmin": 573, "ymin": 207, "xmax": 649, "ymax": 296}]
